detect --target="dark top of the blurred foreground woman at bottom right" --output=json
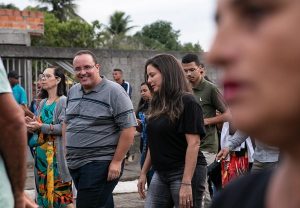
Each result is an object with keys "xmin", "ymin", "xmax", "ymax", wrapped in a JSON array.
[{"xmin": 211, "ymin": 170, "xmax": 273, "ymax": 208}]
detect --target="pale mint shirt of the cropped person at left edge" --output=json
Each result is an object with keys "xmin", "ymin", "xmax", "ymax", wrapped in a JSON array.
[{"xmin": 0, "ymin": 63, "xmax": 14, "ymax": 207}]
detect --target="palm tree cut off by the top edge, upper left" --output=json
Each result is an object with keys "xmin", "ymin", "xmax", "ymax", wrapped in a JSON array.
[{"xmin": 36, "ymin": 0, "xmax": 84, "ymax": 21}]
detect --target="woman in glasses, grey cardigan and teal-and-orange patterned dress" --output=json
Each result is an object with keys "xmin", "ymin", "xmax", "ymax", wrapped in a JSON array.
[{"xmin": 26, "ymin": 67, "xmax": 73, "ymax": 208}]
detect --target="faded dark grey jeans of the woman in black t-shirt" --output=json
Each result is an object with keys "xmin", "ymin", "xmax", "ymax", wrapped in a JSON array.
[{"xmin": 145, "ymin": 165, "xmax": 206, "ymax": 208}]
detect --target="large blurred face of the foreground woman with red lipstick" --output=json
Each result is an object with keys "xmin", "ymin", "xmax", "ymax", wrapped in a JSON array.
[{"xmin": 207, "ymin": 0, "xmax": 300, "ymax": 145}]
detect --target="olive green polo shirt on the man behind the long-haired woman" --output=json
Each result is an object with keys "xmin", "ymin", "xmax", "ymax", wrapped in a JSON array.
[{"xmin": 193, "ymin": 79, "xmax": 226, "ymax": 153}]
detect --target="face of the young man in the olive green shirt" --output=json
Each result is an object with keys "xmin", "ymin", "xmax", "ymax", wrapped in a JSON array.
[{"xmin": 182, "ymin": 62, "xmax": 204, "ymax": 84}]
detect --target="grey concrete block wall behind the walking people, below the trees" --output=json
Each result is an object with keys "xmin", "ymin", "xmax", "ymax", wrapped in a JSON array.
[{"xmin": 0, "ymin": 45, "xmax": 223, "ymax": 107}]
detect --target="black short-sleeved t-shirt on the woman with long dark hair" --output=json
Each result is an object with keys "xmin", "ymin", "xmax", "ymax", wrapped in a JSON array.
[{"xmin": 147, "ymin": 94, "xmax": 206, "ymax": 171}]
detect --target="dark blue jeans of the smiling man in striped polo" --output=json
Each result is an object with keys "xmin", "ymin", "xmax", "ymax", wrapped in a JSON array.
[{"xmin": 69, "ymin": 161, "xmax": 124, "ymax": 208}]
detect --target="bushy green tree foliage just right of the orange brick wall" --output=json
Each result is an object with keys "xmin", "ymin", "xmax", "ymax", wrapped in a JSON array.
[{"xmin": 32, "ymin": 13, "xmax": 103, "ymax": 48}]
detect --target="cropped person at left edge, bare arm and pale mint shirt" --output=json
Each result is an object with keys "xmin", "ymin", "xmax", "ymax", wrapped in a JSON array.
[{"xmin": 0, "ymin": 61, "xmax": 37, "ymax": 208}]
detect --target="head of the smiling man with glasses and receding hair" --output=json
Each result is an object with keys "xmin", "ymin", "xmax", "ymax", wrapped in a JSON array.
[{"xmin": 73, "ymin": 54, "xmax": 101, "ymax": 90}]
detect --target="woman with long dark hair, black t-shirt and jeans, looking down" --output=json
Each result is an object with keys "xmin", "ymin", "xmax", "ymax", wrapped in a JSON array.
[{"xmin": 138, "ymin": 54, "xmax": 206, "ymax": 207}]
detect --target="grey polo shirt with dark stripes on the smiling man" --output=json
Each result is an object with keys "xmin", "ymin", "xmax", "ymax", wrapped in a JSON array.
[{"xmin": 64, "ymin": 77, "xmax": 137, "ymax": 169}]
